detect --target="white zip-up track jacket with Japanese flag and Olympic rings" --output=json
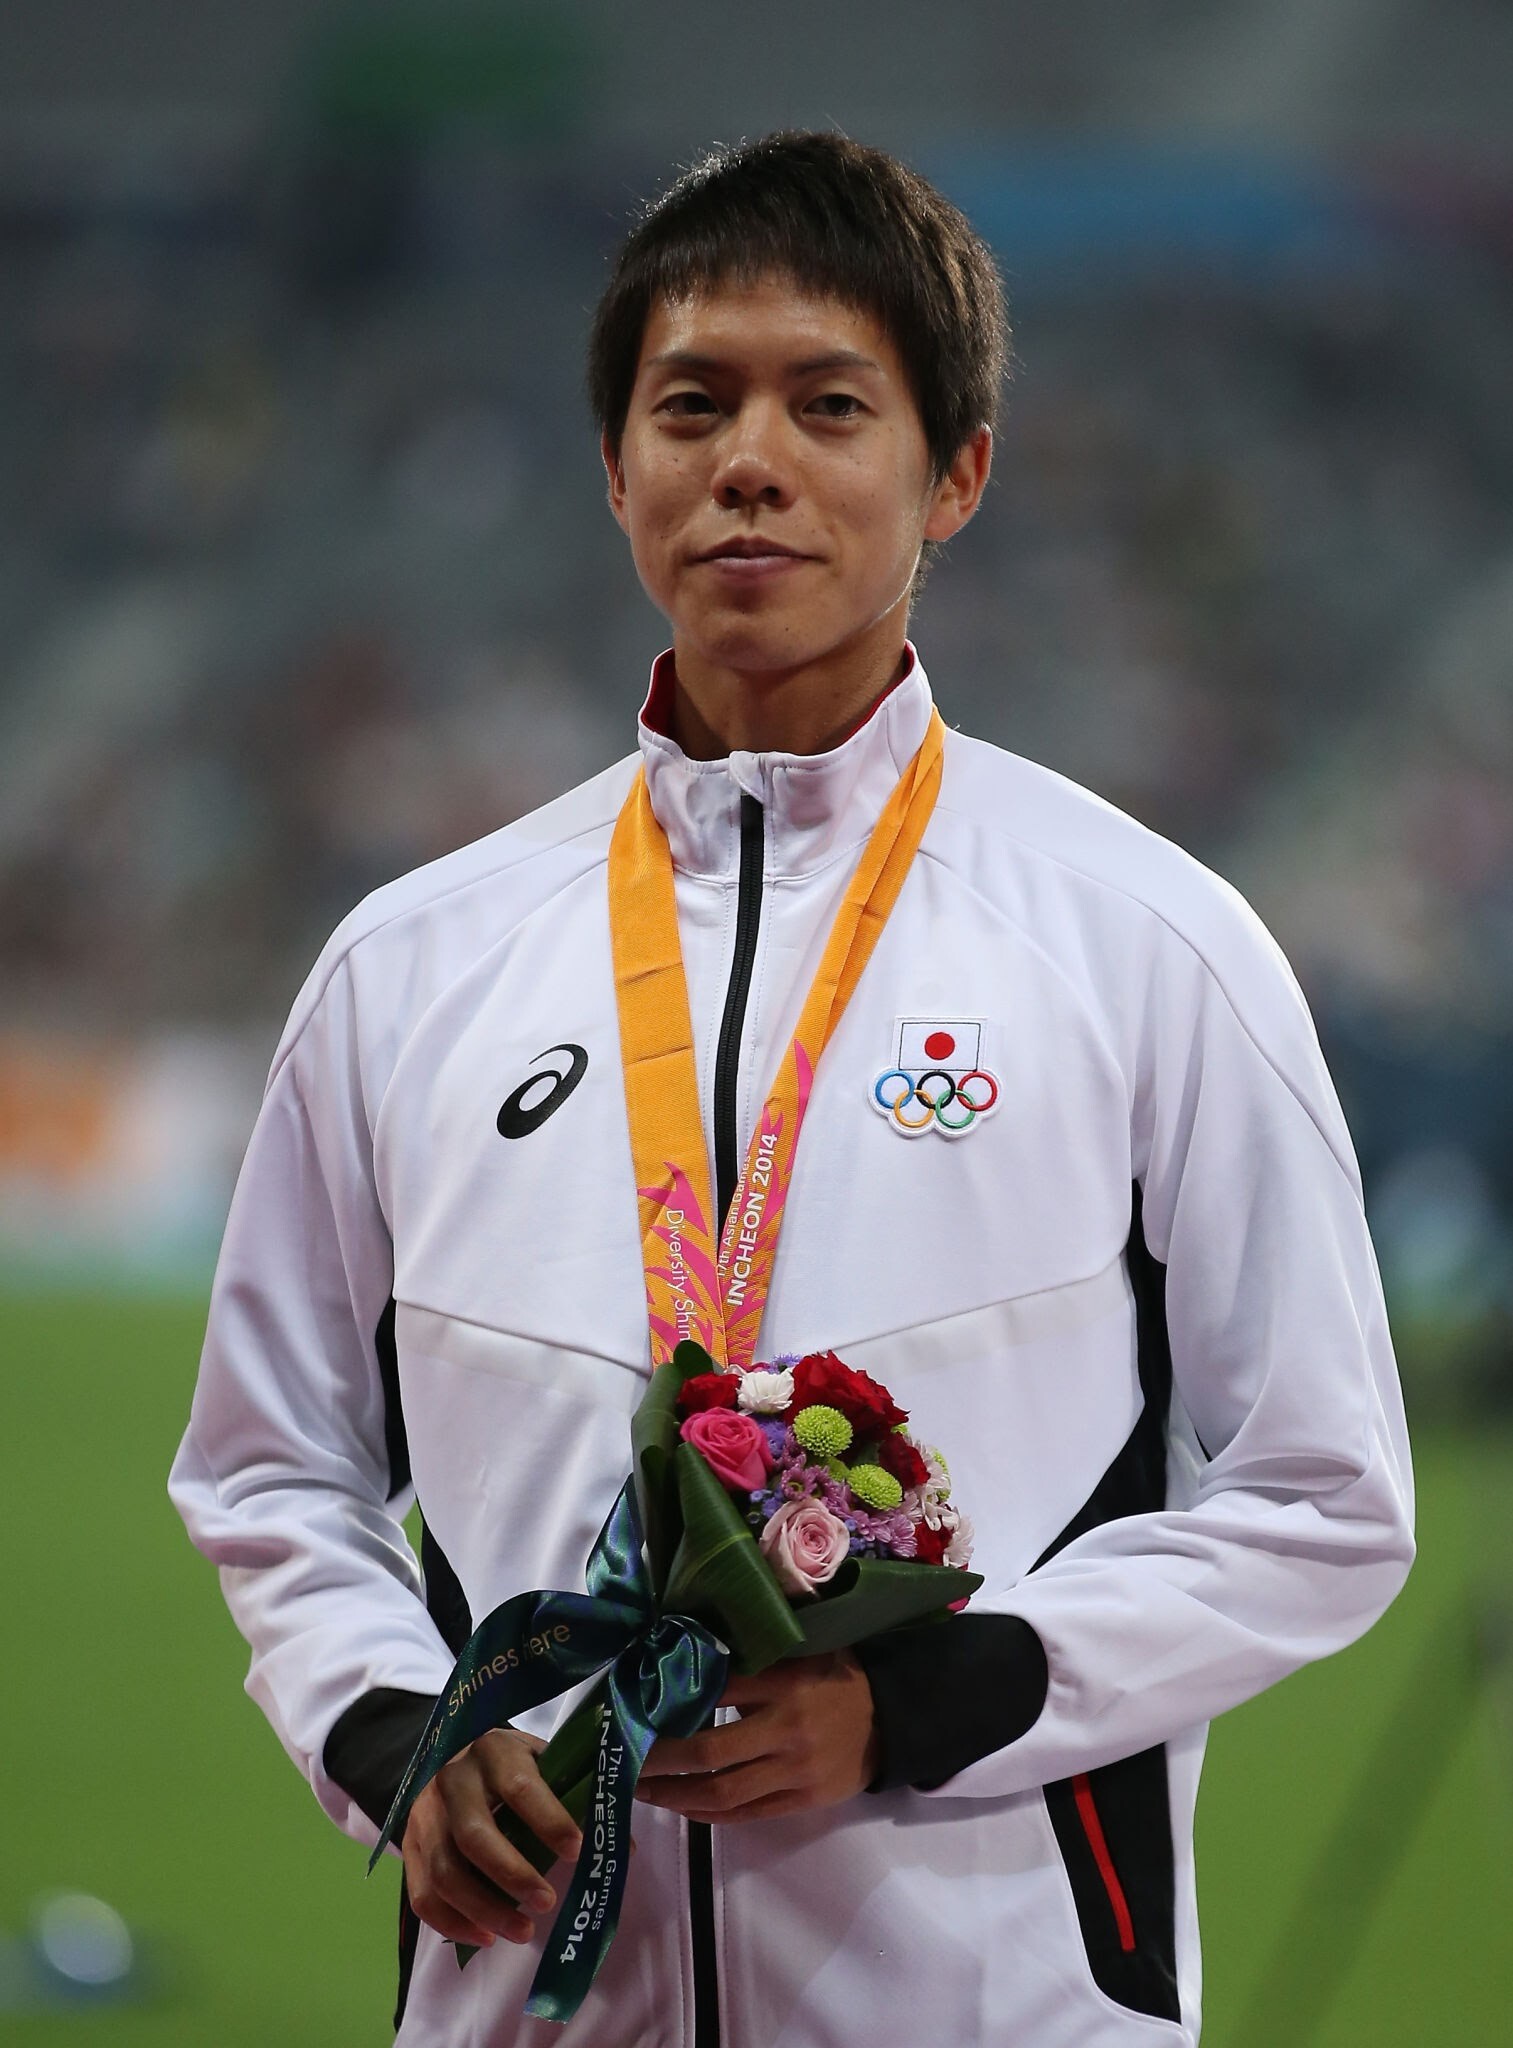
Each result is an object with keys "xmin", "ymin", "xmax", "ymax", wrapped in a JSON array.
[{"xmin": 172, "ymin": 664, "xmax": 1413, "ymax": 2048}]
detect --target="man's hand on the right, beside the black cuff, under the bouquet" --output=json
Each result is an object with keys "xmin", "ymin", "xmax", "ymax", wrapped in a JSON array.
[{"xmin": 637, "ymin": 1651, "xmax": 878, "ymax": 1823}]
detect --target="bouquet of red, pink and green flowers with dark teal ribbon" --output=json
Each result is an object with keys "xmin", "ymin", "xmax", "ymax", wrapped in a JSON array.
[{"xmin": 369, "ymin": 1341, "xmax": 983, "ymax": 2019}]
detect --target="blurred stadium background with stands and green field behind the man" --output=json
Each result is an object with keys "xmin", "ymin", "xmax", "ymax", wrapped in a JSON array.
[{"xmin": 0, "ymin": 0, "xmax": 1513, "ymax": 2048}]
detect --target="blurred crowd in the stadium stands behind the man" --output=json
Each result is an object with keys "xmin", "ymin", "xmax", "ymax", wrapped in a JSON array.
[{"xmin": 0, "ymin": 123, "xmax": 1513, "ymax": 1370}]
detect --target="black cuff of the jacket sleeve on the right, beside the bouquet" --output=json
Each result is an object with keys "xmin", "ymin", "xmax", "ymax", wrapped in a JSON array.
[{"xmin": 854, "ymin": 1614, "xmax": 1050, "ymax": 1792}]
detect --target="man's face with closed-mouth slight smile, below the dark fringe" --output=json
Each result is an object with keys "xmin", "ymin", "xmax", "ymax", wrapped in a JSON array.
[{"xmin": 604, "ymin": 276, "xmax": 977, "ymax": 674}]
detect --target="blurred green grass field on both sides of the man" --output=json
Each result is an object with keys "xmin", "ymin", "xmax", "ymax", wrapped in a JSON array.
[{"xmin": 0, "ymin": 1296, "xmax": 1513, "ymax": 2048}]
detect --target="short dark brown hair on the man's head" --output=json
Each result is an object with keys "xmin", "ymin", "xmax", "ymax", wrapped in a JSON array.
[{"xmin": 588, "ymin": 131, "xmax": 1009, "ymax": 481}]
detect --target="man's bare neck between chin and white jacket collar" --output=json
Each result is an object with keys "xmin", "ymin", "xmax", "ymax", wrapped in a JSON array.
[{"xmin": 669, "ymin": 645, "xmax": 909, "ymax": 762}]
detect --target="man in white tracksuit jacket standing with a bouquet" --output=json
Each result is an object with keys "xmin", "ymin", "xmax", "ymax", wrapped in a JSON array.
[{"xmin": 172, "ymin": 135, "xmax": 1411, "ymax": 2048}]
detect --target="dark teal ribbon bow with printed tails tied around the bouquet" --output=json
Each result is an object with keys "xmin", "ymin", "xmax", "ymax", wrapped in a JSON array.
[{"xmin": 369, "ymin": 1481, "xmax": 729, "ymax": 2019}]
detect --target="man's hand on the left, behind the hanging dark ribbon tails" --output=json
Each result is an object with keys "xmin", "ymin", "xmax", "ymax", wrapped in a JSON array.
[{"xmin": 403, "ymin": 1729, "xmax": 579, "ymax": 1948}]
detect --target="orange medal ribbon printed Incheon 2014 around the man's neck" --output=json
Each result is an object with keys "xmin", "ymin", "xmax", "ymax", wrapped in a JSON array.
[{"xmin": 610, "ymin": 711, "xmax": 946, "ymax": 1372}]
